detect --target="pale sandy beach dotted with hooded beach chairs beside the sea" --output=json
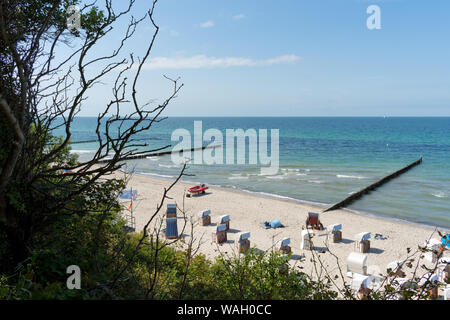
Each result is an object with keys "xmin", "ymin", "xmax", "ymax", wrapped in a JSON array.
[{"xmin": 113, "ymin": 173, "xmax": 449, "ymax": 296}]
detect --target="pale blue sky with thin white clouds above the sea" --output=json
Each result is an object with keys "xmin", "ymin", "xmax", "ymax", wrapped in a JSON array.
[{"xmin": 66, "ymin": 0, "xmax": 450, "ymax": 116}]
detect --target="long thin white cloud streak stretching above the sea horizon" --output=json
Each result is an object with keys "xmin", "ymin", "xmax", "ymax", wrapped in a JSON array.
[{"xmin": 144, "ymin": 54, "xmax": 301, "ymax": 70}]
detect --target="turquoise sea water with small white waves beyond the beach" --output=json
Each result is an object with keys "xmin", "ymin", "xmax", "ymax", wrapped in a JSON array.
[{"xmin": 60, "ymin": 117, "xmax": 450, "ymax": 228}]
